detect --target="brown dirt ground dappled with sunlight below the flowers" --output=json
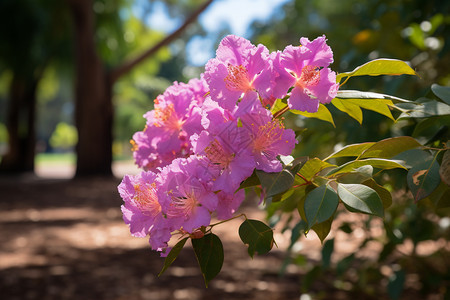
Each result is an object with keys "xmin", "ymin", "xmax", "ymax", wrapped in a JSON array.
[{"xmin": 0, "ymin": 163, "xmax": 448, "ymax": 300}]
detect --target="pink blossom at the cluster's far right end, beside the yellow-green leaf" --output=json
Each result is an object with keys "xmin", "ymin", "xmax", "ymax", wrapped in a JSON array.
[{"xmin": 279, "ymin": 36, "xmax": 339, "ymax": 113}]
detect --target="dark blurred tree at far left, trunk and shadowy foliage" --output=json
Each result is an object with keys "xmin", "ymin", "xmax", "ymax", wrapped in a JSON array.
[{"xmin": 0, "ymin": 0, "xmax": 70, "ymax": 172}]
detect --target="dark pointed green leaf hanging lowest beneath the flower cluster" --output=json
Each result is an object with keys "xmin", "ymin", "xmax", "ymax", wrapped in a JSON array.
[{"xmin": 192, "ymin": 233, "xmax": 224, "ymax": 287}]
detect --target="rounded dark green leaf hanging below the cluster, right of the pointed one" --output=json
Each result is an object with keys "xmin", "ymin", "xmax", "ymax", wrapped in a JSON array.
[{"xmin": 239, "ymin": 219, "xmax": 274, "ymax": 258}]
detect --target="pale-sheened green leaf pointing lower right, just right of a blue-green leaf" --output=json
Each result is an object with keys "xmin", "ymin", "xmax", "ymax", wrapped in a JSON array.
[{"xmin": 338, "ymin": 183, "xmax": 384, "ymax": 217}]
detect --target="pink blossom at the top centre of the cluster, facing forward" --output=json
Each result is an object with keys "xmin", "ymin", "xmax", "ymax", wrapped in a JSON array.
[{"xmin": 205, "ymin": 35, "xmax": 271, "ymax": 110}]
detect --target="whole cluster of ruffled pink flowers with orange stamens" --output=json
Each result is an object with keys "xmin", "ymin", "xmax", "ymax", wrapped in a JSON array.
[{"xmin": 119, "ymin": 35, "xmax": 338, "ymax": 255}]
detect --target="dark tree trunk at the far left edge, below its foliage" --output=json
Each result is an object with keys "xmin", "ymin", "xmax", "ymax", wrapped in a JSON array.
[{"xmin": 0, "ymin": 75, "xmax": 38, "ymax": 173}]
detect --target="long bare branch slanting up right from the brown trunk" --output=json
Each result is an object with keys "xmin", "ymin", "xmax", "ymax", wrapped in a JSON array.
[{"xmin": 110, "ymin": 0, "xmax": 214, "ymax": 82}]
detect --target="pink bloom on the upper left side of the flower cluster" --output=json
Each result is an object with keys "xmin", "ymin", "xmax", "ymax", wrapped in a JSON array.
[{"xmin": 132, "ymin": 79, "xmax": 206, "ymax": 171}]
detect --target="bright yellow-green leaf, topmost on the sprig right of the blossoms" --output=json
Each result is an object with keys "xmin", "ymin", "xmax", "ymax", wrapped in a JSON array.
[{"xmin": 336, "ymin": 58, "xmax": 417, "ymax": 85}]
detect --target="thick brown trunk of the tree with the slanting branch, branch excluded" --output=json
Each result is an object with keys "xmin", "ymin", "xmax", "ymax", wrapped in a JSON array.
[{"xmin": 69, "ymin": 0, "xmax": 113, "ymax": 177}]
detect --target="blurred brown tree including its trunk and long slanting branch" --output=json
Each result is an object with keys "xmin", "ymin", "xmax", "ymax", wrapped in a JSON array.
[{"xmin": 68, "ymin": 0, "xmax": 212, "ymax": 176}]
